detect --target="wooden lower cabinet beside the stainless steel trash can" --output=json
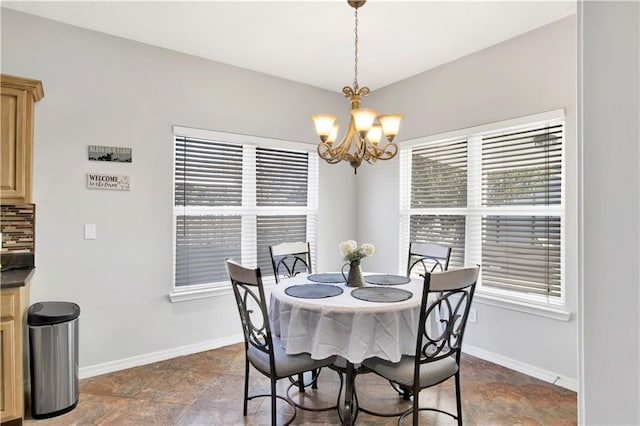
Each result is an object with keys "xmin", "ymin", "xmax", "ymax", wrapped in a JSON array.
[{"xmin": 0, "ymin": 286, "xmax": 29, "ymax": 424}]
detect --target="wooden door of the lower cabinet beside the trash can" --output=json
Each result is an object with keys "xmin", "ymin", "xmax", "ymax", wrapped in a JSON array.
[{"xmin": 0, "ymin": 320, "xmax": 22, "ymax": 421}]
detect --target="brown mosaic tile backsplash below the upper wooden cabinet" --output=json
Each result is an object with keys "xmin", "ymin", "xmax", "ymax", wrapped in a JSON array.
[{"xmin": 0, "ymin": 204, "xmax": 36, "ymax": 253}]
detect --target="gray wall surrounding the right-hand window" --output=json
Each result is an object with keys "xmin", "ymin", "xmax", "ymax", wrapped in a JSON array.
[{"xmin": 358, "ymin": 15, "xmax": 578, "ymax": 389}]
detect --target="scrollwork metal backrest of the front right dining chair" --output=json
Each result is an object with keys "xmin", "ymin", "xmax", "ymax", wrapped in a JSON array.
[{"xmin": 416, "ymin": 266, "xmax": 480, "ymax": 371}]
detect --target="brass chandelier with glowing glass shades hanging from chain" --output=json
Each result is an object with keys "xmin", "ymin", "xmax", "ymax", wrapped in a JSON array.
[{"xmin": 311, "ymin": 0, "xmax": 402, "ymax": 173}]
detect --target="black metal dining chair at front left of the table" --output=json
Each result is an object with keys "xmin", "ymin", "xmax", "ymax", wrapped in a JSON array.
[{"xmin": 226, "ymin": 259, "xmax": 335, "ymax": 426}]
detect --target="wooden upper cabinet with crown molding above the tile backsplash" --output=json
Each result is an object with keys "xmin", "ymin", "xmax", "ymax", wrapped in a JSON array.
[{"xmin": 0, "ymin": 74, "xmax": 44, "ymax": 204}]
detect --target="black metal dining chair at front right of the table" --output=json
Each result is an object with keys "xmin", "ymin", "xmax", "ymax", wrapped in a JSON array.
[{"xmin": 359, "ymin": 267, "xmax": 480, "ymax": 426}]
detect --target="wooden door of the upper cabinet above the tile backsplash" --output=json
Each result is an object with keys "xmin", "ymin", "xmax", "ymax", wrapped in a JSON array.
[{"xmin": 0, "ymin": 87, "xmax": 32, "ymax": 204}]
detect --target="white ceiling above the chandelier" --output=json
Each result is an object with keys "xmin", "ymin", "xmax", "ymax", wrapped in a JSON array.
[{"xmin": 1, "ymin": 0, "xmax": 576, "ymax": 92}]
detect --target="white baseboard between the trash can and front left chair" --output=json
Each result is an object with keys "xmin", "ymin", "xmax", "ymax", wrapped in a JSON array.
[{"xmin": 78, "ymin": 334, "xmax": 244, "ymax": 379}]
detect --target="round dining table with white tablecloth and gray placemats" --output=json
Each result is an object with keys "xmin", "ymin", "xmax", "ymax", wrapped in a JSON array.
[{"xmin": 269, "ymin": 273, "xmax": 423, "ymax": 425}]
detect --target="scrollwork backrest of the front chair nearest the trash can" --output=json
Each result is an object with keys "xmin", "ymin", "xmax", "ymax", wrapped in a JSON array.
[{"xmin": 226, "ymin": 259, "xmax": 275, "ymax": 371}]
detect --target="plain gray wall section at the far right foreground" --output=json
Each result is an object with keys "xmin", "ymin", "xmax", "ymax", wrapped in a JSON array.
[{"xmin": 579, "ymin": 1, "xmax": 640, "ymax": 425}]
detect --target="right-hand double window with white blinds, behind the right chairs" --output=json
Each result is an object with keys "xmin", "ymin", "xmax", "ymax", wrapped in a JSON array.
[{"xmin": 401, "ymin": 112, "xmax": 564, "ymax": 304}]
